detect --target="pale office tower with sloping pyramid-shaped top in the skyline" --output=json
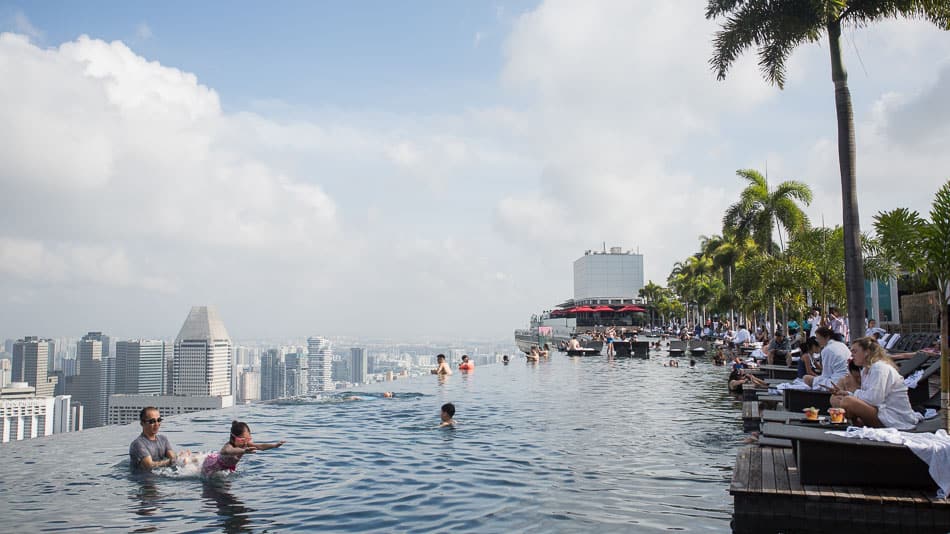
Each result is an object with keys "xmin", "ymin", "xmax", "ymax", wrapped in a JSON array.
[{"xmin": 172, "ymin": 306, "xmax": 232, "ymax": 396}]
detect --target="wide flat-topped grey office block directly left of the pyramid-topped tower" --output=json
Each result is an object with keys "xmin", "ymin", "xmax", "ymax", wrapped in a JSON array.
[{"xmin": 115, "ymin": 339, "xmax": 167, "ymax": 395}]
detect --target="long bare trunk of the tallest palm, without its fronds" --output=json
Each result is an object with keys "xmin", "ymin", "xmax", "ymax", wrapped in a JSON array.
[{"xmin": 828, "ymin": 19, "xmax": 865, "ymax": 340}]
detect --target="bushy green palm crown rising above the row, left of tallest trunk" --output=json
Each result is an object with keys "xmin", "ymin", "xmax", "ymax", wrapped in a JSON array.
[{"xmin": 722, "ymin": 169, "xmax": 812, "ymax": 254}]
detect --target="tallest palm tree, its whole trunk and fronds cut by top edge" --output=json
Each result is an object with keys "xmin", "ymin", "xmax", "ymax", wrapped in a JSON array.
[{"xmin": 706, "ymin": 0, "xmax": 950, "ymax": 339}]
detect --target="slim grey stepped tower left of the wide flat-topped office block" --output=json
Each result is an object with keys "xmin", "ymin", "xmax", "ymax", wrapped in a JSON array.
[{"xmin": 73, "ymin": 332, "xmax": 108, "ymax": 428}]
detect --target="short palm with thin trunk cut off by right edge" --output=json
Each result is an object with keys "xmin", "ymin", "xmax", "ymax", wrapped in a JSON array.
[{"xmin": 874, "ymin": 180, "xmax": 950, "ymax": 429}]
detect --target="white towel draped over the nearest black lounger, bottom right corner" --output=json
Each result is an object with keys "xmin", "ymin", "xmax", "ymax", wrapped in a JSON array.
[{"xmin": 825, "ymin": 426, "xmax": 950, "ymax": 499}]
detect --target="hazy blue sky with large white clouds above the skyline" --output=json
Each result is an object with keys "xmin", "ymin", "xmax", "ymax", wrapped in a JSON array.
[{"xmin": 0, "ymin": 0, "xmax": 950, "ymax": 340}]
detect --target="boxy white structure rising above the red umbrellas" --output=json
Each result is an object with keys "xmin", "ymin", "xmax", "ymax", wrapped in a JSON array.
[{"xmin": 574, "ymin": 247, "xmax": 643, "ymax": 304}]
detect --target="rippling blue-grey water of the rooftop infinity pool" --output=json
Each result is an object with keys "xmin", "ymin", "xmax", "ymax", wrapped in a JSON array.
[{"xmin": 0, "ymin": 354, "xmax": 743, "ymax": 532}]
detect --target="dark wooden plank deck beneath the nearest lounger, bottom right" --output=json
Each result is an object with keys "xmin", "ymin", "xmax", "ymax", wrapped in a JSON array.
[{"xmin": 729, "ymin": 446, "xmax": 950, "ymax": 534}]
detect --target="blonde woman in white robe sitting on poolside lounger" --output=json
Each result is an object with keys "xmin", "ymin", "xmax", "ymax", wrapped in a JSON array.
[{"xmin": 831, "ymin": 337, "xmax": 922, "ymax": 430}]
